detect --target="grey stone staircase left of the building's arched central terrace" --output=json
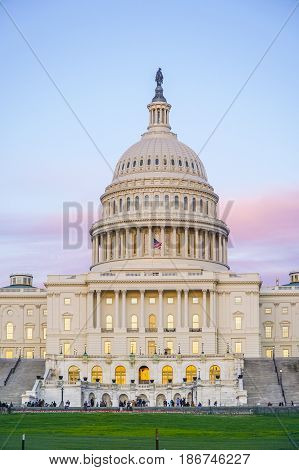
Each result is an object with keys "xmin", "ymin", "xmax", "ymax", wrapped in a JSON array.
[{"xmin": 0, "ymin": 359, "xmax": 45, "ymax": 405}]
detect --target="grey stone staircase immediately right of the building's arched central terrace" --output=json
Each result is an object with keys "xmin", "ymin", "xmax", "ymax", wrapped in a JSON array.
[{"xmin": 244, "ymin": 358, "xmax": 284, "ymax": 406}]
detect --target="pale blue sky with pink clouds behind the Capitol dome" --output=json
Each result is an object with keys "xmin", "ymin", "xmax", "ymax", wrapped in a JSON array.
[{"xmin": 0, "ymin": 0, "xmax": 299, "ymax": 286}]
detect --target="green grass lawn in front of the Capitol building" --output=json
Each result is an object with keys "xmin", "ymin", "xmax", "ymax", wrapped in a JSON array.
[{"xmin": 0, "ymin": 413, "xmax": 299, "ymax": 450}]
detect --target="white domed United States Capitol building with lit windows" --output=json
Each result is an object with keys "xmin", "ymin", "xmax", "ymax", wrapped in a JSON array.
[{"xmin": 0, "ymin": 69, "xmax": 299, "ymax": 406}]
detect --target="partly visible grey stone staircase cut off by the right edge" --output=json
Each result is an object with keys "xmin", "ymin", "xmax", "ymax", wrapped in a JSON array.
[{"xmin": 275, "ymin": 357, "xmax": 299, "ymax": 405}]
